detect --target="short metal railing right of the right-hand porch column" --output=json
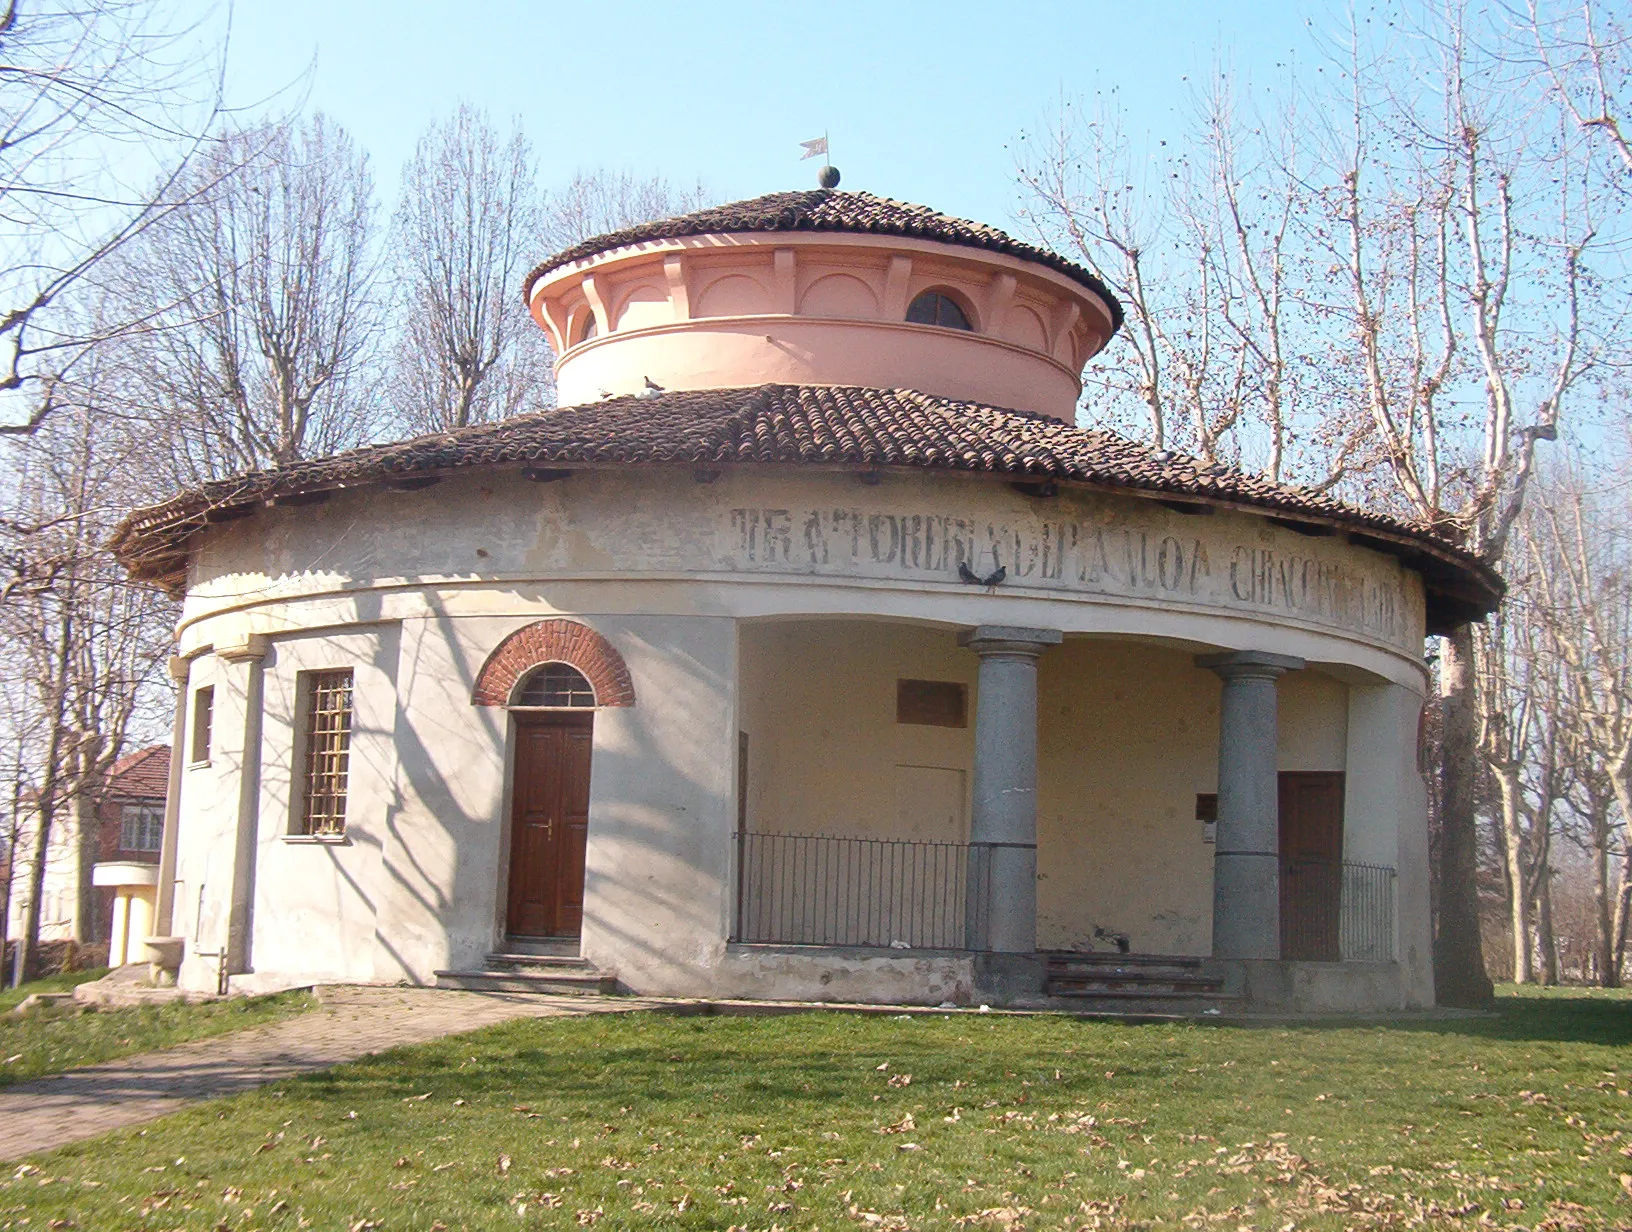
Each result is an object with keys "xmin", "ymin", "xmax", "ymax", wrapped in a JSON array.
[{"xmin": 1281, "ymin": 857, "xmax": 1394, "ymax": 963}]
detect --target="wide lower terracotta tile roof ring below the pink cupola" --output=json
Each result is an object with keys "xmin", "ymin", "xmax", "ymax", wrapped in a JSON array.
[{"xmin": 113, "ymin": 385, "xmax": 1501, "ymax": 620}]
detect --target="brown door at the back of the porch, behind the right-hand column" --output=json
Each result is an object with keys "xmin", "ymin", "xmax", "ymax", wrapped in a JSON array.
[{"xmin": 1279, "ymin": 770, "xmax": 1343, "ymax": 963}]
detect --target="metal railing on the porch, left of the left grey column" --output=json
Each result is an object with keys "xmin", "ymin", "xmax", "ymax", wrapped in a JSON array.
[{"xmin": 736, "ymin": 832, "xmax": 982, "ymax": 950}]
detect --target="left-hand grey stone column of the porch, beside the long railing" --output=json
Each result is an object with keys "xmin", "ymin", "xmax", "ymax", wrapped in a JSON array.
[{"xmin": 958, "ymin": 625, "xmax": 1061, "ymax": 955}]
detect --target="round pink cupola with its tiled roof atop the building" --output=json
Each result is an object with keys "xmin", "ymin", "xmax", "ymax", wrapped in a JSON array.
[{"xmin": 526, "ymin": 188, "xmax": 1121, "ymax": 423}]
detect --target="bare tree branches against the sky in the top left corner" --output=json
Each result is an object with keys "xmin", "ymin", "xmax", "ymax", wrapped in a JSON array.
[{"xmin": 0, "ymin": 0, "xmax": 224, "ymax": 436}]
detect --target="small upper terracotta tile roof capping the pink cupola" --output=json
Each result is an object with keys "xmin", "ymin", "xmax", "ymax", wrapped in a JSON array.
[{"xmin": 522, "ymin": 188, "xmax": 1123, "ymax": 328}]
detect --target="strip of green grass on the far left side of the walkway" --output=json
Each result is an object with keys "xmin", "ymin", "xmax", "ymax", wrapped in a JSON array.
[{"xmin": 0, "ymin": 971, "xmax": 317, "ymax": 1090}]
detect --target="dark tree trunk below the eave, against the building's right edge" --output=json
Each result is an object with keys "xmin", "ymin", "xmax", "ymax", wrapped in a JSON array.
[{"xmin": 1433, "ymin": 625, "xmax": 1494, "ymax": 1008}]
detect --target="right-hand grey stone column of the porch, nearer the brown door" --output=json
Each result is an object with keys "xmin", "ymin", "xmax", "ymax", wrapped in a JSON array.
[{"xmin": 1196, "ymin": 651, "xmax": 1304, "ymax": 961}]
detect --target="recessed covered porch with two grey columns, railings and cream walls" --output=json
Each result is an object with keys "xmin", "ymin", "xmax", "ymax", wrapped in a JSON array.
[{"xmin": 730, "ymin": 618, "xmax": 1415, "ymax": 1008}]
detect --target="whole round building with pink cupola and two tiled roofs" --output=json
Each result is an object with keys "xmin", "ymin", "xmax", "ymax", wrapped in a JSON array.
[{"xmin": 116, "ymin": 189, "xmax": 1500, "ymax": 1012}]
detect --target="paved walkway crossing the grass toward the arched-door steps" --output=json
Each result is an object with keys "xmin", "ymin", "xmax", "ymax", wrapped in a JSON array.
[{"xmin": 0, "ymin": 987, "xmax": 654, "ymax": 1160}]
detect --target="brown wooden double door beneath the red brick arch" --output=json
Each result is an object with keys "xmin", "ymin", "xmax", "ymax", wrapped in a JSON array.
[{"xmin": 506, "ymin": 710, "xmax": 594, "ymax": 937}]
